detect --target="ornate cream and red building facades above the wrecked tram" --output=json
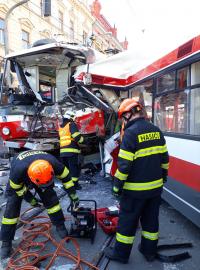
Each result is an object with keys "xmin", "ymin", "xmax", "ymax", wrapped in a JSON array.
[{"xmin": 0, "ymin": 0, "xmax": 128, "ymax": 70}]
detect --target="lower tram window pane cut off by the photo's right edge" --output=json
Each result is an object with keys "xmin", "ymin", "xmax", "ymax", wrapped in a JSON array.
[{"xmin": 190, "ymin": 88, "xmax": 200, "ymax": 135}]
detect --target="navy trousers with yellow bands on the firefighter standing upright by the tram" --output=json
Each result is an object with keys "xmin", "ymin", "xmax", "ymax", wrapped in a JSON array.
[{"xmin": 114, "ymin": 194, "xmax": 161, "ymax": 259}]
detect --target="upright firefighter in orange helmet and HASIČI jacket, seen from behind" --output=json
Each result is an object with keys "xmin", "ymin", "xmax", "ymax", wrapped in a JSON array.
[{"xmin": 104, "ymin": 98, "xmax": 169, "ymax": 263}]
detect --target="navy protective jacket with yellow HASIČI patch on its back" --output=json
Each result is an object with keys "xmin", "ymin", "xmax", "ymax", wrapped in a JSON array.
[{"xmin": 115, "ymin": 118, "xmax": 169, "ymax": 198}]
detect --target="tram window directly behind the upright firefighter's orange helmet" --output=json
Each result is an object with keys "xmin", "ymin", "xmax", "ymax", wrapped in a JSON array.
[{"xmin": 130, "ymin": 80, "xmax": 153, "ymax": 120}]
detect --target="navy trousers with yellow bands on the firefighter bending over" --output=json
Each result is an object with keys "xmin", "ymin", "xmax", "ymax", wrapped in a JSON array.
[{"xmin": 1, "ymin": 187, "xmax": 65, "ymax": 241}]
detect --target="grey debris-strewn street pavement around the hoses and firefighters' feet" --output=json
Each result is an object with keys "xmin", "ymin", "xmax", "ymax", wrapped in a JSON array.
[{"xmin": 0, "ymin": 168, "xmax": 200, "ymax": 270}]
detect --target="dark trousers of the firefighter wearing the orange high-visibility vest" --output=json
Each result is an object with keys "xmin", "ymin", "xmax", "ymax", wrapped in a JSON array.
[{"xmin": 62, "ymin": 154, "xmax": 80, "ymax": 183}]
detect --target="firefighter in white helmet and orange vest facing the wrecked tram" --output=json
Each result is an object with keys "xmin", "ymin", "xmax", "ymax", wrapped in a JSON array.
[{"xmin": 59, "ymin": 113, "xmax": 84, "ymax": 189}]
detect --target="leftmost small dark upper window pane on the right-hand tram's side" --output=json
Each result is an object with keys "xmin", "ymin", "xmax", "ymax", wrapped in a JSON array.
[{"xmin": 156, "ymin": 71, "xmax": 175, "ymax": 93}]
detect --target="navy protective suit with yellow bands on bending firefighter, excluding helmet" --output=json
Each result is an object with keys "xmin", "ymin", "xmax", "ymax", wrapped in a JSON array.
[{"xmin": 0, "ymin": 150, "xmax": 76, "ymax": 241}]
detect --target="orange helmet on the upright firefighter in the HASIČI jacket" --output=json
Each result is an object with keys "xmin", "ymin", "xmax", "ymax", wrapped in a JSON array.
[{"xmin": 118, "ymin": 98, "xmax": 142, "ymax": 119}]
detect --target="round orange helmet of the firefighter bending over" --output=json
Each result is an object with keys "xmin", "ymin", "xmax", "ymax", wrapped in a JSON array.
[{"xmin": 28, "ymin": 159, "xmax": 54, "ymax": 187}]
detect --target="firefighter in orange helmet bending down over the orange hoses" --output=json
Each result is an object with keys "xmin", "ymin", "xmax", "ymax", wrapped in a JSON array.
[{"xmin": 0, "ymin": 150, "xmax": 79, "ymax": 259}]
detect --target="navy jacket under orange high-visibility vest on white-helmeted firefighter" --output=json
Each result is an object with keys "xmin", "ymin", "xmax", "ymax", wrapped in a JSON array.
[{"xmin": 59, "ymin": 121, "xmax": 84, "ymax": 157}]
